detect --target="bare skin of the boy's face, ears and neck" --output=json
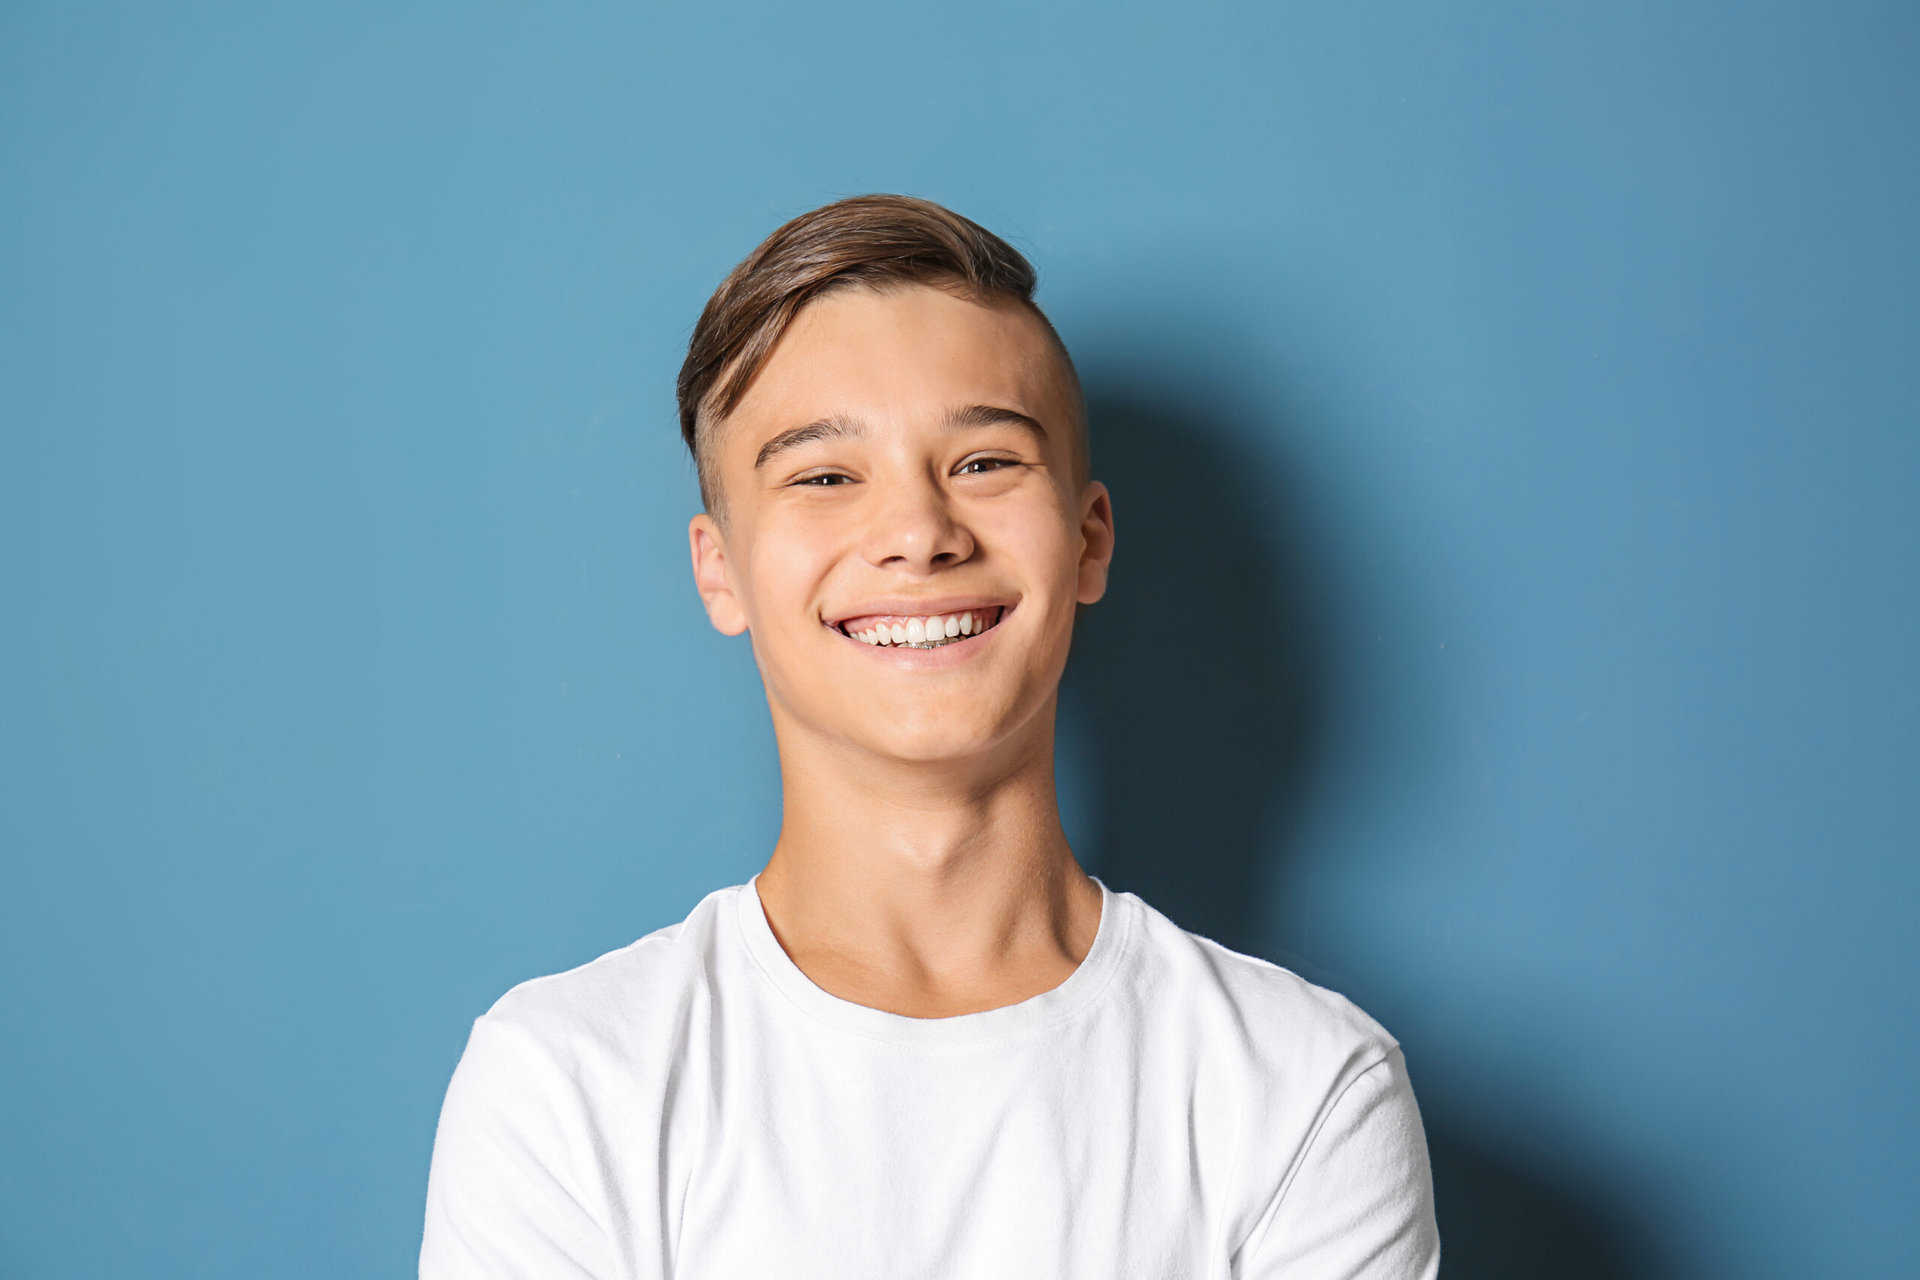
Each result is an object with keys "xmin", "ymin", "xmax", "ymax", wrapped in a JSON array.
[{"xmin": 687, "ymin": 286, "xmax": 1114, "ymax": 1017}]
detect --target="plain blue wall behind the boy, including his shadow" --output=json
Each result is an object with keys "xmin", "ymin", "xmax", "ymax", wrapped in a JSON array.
[{"xmin": 0, "ymin": 0, "xmax": 1920, "ymax": 1278}]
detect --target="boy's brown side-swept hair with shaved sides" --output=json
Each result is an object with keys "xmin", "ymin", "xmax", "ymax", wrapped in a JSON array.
[{"xmin": 678, "ymin": 194, "xmax": 1092, "ymax": 524}]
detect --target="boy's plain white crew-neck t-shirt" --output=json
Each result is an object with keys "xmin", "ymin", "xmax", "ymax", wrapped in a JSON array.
[{"xmin": 420, "ymin": 875, "xmax": 1440, "ymax": 1280}]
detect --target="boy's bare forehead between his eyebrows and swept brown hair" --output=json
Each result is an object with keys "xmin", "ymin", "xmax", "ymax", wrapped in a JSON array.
[{"xmin": 728, "ymin": 286, "xmax": 1064, "ymax": 445}]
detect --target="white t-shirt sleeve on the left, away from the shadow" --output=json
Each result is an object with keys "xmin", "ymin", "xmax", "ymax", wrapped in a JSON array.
[{"xmin": 420, "ymin": 1015, "xmax": 612, "ymax": 1280}]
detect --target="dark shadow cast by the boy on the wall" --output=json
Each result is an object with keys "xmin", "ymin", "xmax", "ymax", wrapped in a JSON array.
[{"xmin": 1062, "ymin": 357, "xmax": 1672, "ymax": 1280}]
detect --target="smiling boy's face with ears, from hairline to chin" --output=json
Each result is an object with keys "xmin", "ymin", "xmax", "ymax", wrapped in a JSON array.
[{"xmin": 687, "ymin": 286, "xmax": 1114, "ymax": 760}]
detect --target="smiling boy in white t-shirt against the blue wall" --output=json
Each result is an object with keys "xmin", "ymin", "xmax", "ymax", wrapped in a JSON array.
[{"xmin": 420, "ymin": 196, "xmax": 1440, "ymax": 1280}]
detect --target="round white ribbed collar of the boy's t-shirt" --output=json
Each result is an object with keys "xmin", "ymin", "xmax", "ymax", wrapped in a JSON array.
[{"xmin": 733, "ymin": 873, "xmax": 1135, "ymax": 1046}]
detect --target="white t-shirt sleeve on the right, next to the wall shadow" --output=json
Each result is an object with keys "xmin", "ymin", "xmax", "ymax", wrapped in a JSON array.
[{"xmin": 1235, "ymin": 1046, "xmax": 1440, "ymax": 1280}]
